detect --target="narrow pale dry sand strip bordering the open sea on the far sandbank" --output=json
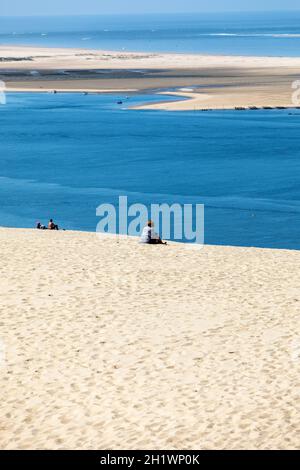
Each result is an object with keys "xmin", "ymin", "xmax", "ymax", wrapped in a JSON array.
[{"xmin": 0, "ymin": 45, "xmax": 300, "ymax": 71}]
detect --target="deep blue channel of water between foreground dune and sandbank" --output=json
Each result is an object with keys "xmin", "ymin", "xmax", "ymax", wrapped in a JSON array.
[{"xmin": 0, "ymin": 93, "xmax": 300, "ymax": 249}]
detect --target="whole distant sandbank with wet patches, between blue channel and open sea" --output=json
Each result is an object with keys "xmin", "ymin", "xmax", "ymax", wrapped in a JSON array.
[{"xmin": 0, "ymin": 46, "xmax": 300, "ymax": 111}]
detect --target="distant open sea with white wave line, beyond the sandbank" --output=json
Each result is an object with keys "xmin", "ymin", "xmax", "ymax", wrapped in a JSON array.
[{"xmin": 0, "ymin": 12, "xmax": 300, "ymax": 56}]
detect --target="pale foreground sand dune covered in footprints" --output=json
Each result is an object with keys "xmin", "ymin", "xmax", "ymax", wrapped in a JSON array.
[{"xmin": 0, "ymin": 229, "xmax": 300, "ymax": 449}]
